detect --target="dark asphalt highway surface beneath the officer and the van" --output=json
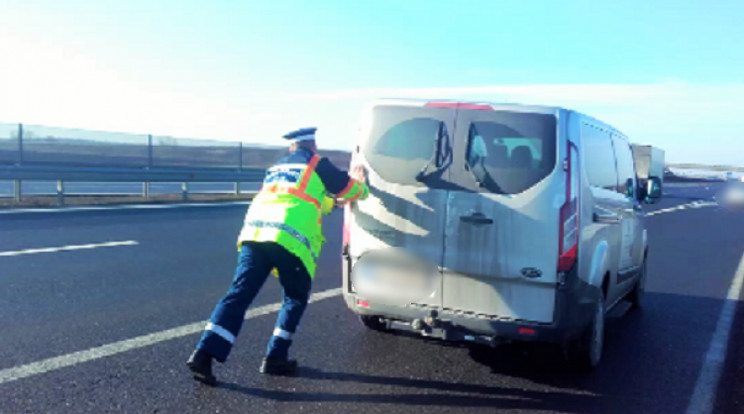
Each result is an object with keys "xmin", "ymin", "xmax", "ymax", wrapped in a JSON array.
[{"xmin": 0, "ymin": 184, "xmax": 744, "ymax": 413}]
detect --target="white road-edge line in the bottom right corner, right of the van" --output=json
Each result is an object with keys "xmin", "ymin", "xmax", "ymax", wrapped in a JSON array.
[{"xmin": 687, "ymin": 251, "xmax": 744, "ymax": 414}]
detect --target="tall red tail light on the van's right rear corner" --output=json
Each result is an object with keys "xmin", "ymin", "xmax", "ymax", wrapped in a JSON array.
[{"xmin": 558, "ymin": 142, "xmax": 579, "ymax": 272}]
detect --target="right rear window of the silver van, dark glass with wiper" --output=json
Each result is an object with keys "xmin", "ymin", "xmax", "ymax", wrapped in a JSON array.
[{"xmin": 466, "ymin": 112, "xmax": 556, "ymax": 194}]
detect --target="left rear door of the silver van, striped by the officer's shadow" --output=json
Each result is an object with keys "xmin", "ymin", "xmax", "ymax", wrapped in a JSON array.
[{"xmin": 348, "ymin": 103, "xmax": 455, "ymax": 306}]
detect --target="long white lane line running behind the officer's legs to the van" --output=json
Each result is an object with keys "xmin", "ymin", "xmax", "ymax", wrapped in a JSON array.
[{"xmin": 0, "ymin": 288, "xmax": 341, "ymax": 384}]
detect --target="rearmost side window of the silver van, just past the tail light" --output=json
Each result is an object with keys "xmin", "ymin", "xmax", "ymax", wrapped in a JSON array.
[{"xmin": 581, "ymin": 124, "xmax": 617, "ymax": 191}]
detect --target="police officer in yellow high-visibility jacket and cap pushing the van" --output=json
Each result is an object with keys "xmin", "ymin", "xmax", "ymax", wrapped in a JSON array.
[{"xmin": 186, "ymin": 128, "xmax": 369, "ymax": 385}]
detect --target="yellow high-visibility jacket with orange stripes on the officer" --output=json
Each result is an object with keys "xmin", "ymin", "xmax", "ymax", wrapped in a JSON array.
[{"xmin": 238, "ymin": 155, "xmax": 369, "ymax": 278}]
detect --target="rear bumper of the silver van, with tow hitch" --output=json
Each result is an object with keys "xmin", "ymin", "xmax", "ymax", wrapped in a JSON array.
[{"xmin": 343, "ymin": 258, "xmax": 601, "ymax": 345}]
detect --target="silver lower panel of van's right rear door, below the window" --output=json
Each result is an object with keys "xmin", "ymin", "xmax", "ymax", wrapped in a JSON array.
[{"xmin": 442, "ymin": 182, "xmax": 558, "ymax": 322}]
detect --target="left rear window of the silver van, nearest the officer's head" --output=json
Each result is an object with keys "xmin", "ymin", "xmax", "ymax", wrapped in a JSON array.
[{"xmin": 362, "ymin": 107, "xmax": 447, "ymax": 185}]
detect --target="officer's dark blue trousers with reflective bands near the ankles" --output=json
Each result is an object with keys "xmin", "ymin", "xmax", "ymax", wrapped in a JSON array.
[{"xmin": 196, "ymin": 242, "xmax": 311, "ymax": 362}]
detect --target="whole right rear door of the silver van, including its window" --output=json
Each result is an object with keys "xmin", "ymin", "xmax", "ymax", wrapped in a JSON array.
[{"xmin": 442, "ymin": 106, "xmax": 566, "ymax": 323}]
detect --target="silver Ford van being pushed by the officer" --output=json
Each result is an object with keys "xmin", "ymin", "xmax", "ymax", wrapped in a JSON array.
[{"xmin": 343, "ymin": 100, "xmax": 660, "ymax": 367}]
